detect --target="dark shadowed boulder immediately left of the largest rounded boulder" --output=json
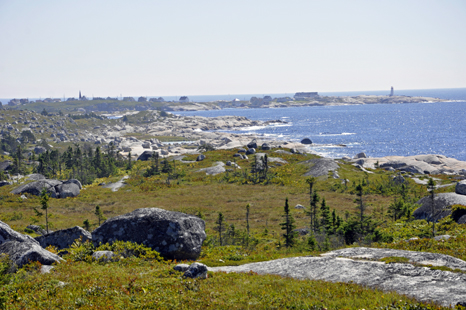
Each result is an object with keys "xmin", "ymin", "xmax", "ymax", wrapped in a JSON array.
[{"xmin": 35, "ymin": 226, "xmax": 92, "ymax": 250}]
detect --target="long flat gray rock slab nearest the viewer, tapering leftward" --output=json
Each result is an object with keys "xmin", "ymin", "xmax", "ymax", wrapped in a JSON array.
[{"xmin": 209, "ymin": 253, "xmax": 466, "ymax": 306}]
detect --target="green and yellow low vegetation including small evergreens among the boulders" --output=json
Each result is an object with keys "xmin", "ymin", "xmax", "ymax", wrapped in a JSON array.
[{"xmin": 0, "ymin": 142, "xmax": 466, "ymax": 309}]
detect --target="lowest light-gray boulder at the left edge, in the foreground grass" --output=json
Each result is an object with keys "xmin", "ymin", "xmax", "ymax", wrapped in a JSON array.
[{"xmin": 0, "ymin": 241, "xmax": 61, "ymax": 267}]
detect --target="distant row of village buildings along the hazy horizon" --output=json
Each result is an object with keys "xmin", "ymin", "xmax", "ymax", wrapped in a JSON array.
[{"xmin": 0, "ymin": 92, "xmax": 319, "ymax": 107}]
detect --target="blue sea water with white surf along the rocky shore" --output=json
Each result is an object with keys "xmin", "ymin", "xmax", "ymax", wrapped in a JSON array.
[{"xmin": 176, "ymin": 89, "xmax": 466, "ymax": 161}]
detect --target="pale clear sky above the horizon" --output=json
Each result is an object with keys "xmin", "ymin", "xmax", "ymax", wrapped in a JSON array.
[{"xmin": 0, "ymin": 0, "xmax": 466, "ymax": 98}]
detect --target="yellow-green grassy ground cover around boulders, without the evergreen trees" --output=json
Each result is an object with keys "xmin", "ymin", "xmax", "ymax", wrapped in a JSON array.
[{"xmin": 0, "ymin": 150, "xmax": 466, "ymax": 309}]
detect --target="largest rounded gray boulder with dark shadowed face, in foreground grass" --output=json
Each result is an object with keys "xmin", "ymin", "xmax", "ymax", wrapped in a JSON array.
[{"xmin": 92, "ymin": 208, "xmax": 206, "ymax": 260}]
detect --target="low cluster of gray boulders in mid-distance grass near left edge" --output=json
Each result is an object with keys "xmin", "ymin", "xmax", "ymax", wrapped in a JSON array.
[{"xmin": 11, "ymin": 179, "xmax": 82, "ymax": 198}]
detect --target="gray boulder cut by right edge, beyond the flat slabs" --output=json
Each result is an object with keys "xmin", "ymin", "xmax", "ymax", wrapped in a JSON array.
[{"xmin": 413, "ymin": 193, "xmax": 466, "ymax": 221}]
